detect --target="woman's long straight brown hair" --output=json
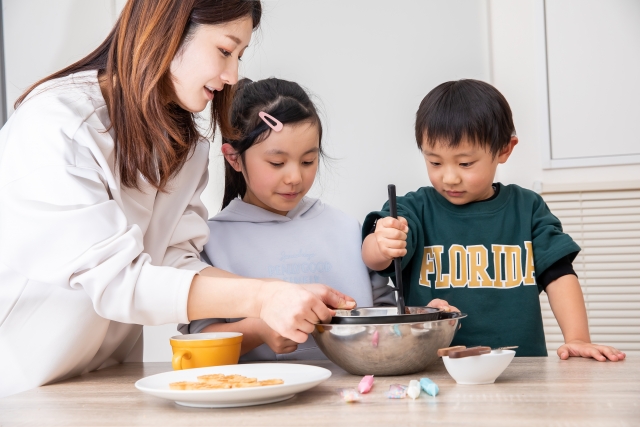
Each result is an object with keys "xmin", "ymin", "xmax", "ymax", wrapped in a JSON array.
[{"xmin": 15, "ymin": 0, "xmax": 262, "ymax": 190}]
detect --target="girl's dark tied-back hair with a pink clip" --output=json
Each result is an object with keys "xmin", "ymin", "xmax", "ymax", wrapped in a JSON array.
[{"xmin": 222, "ymin": 77, "xmax": 323, "ymax": 209}]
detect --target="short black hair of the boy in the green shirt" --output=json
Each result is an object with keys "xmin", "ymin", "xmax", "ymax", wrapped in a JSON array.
[{"xmin": 416, "ymin": 79, "xmax": 516, "ymax": 157}]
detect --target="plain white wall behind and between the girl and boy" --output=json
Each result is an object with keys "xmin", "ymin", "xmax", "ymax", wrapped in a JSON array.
[{"xmin": 205, "ymin": 0, "xmax": 490, "ymax": 220}]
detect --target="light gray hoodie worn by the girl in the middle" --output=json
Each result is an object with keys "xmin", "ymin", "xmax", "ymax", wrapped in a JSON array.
[{"xmin": 180, "ymin": 197, "xmax": 396, "ymax": 361}]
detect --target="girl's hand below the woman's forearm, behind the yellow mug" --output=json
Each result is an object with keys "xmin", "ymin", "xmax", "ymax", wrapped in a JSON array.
[{"xmin": 201, "ymin": 317, "xmax": 298, "ymax": 355}]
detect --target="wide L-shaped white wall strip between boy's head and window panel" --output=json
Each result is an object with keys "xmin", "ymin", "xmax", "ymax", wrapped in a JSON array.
[{"xmin": 489, "ymin": 0, "xmax": 640, "ymax": 188}]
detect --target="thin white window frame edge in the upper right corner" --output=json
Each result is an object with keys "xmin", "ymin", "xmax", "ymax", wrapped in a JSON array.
[{"xmin": 535, "ymin": 0, "xmax": 640, "ymax": 169}]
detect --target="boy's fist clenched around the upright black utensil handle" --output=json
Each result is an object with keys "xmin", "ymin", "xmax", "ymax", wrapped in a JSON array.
[{"xmin": 362, "ymin": 217, "xmax": 409, "ymax": 271}]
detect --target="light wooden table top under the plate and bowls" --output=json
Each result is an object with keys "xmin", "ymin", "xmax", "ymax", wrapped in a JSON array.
[{"xmin": 0, "ymin": 355, "xmax": 640, "ymax": 427}]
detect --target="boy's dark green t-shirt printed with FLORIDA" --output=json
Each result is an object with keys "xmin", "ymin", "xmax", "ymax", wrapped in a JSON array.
[{"xmin": 362, "ymin": 183, "xmax": 580, "ymax": 356}]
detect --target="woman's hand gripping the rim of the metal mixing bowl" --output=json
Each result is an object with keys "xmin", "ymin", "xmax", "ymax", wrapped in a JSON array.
[{"xmin": 258, "ymin": 281, "xmax": 355, "ymax": 343}]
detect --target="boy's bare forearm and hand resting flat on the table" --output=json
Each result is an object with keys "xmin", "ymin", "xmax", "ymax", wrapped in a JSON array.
[{"xmin": 545, "ymin": 274, "xmax": 626, "ymax": 362}]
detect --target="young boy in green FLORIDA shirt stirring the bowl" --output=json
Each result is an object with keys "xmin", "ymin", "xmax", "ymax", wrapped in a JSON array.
[{"xmin": 362, "ymin": 80, "xmax": 625, "ymax": 361}]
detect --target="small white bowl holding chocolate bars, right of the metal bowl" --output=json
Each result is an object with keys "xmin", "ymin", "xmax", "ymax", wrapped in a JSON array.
[{"xmin": 442, "ymin": 350, "xmax": 516, "ymax": 384}]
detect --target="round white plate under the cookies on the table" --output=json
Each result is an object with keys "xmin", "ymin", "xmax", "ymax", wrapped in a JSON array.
[{"xmin": 136, "ymin": 363, "xmax": 331, "ymax": 408}]
